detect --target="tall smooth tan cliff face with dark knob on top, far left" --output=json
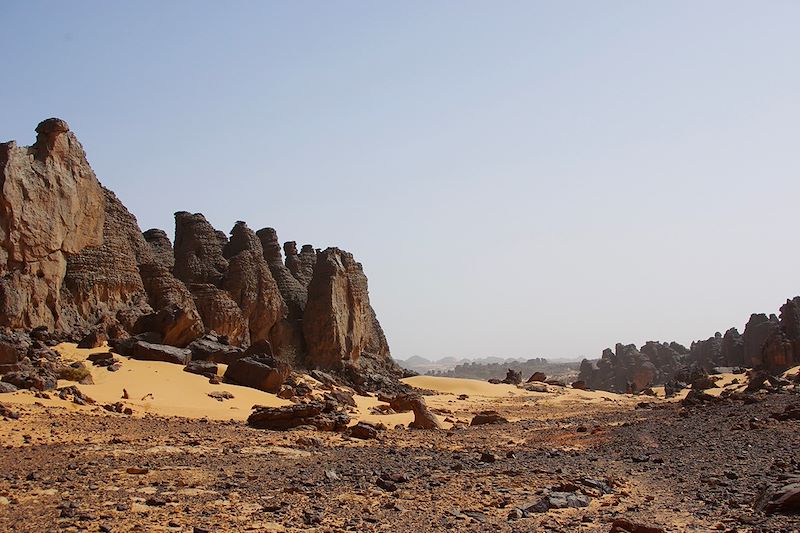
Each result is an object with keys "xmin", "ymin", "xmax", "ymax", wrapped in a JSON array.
[{"xmin": 0, "ymin": 119, "xmax": 105, "ymax": 330}]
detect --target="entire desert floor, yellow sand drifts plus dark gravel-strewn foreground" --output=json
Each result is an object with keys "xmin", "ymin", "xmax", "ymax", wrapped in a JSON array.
[{"xmin": 0, "ymin": 345, "xmax": 800, "ymax": 532}]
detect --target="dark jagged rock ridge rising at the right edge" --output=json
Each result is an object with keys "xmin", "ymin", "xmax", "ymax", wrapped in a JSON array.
[{"xmin": 578, "ymin": 296, "xmax": 800, "ymax": 392}]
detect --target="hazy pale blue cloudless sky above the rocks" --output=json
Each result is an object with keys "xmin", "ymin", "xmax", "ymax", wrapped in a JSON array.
[{"xmin": 0, "ymin": 0, "xmax": 800, "ymax": 359}]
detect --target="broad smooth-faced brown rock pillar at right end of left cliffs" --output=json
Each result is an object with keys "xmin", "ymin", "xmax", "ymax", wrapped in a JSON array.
[{"xmin": 303, "ymin": 248, "xmax": 389, "ymax": 369}]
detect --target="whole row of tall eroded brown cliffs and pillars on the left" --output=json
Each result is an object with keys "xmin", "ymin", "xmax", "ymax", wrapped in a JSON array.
[{"xmin": 0, "ymin": 119, "xmax": 401, "ymax": 383}]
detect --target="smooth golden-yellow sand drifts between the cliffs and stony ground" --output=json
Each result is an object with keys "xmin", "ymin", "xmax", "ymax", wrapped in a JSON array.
[{"xmin": 3, "ymin": 343, "xmax": 712, "ymax": 428}]
